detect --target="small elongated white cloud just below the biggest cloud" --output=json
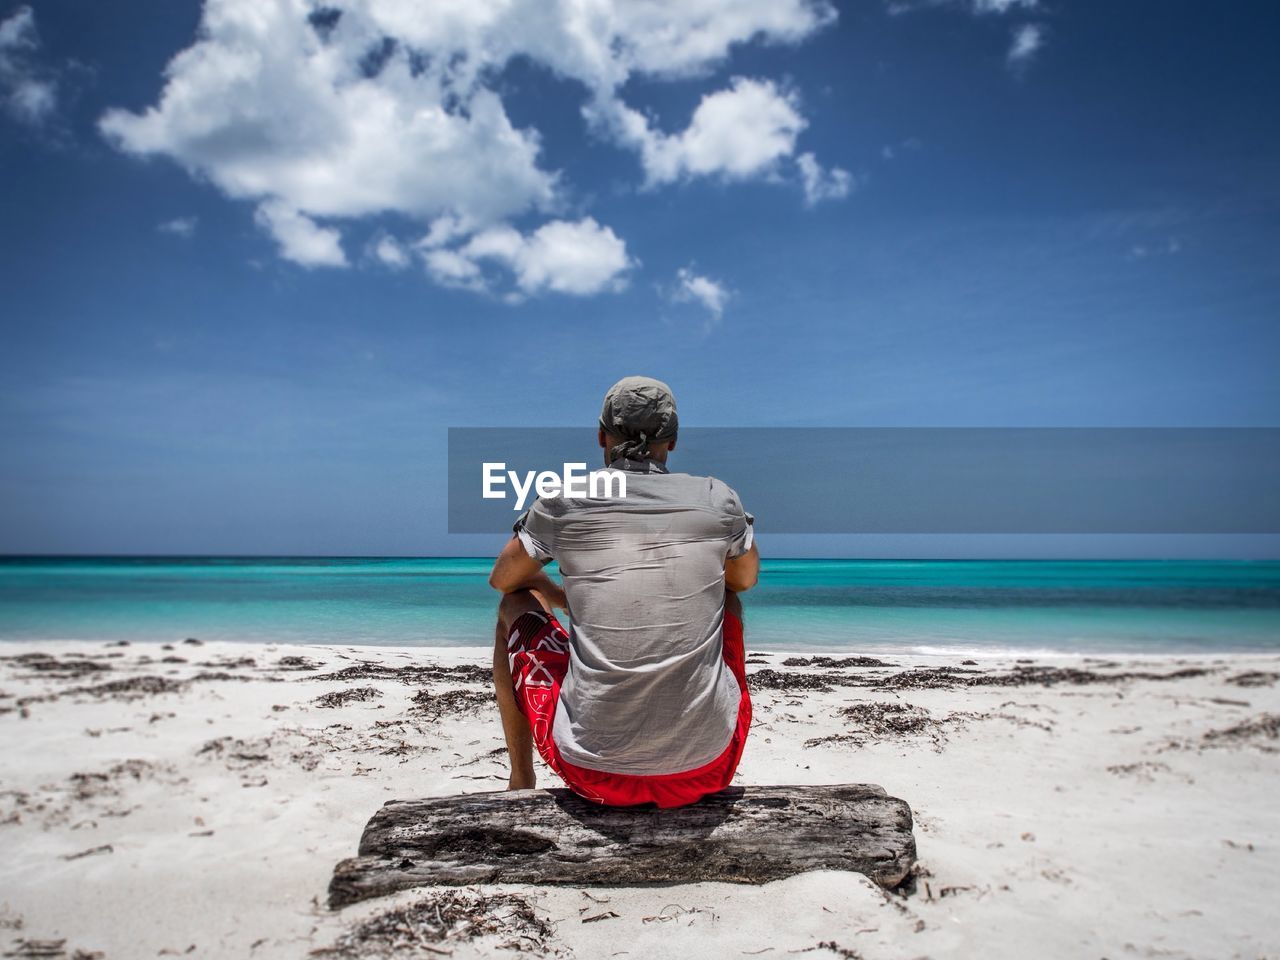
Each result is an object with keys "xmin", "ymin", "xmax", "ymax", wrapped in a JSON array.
[{"xmin": 420, "ymin": 216, "xmax": 635, "ymax": 296}]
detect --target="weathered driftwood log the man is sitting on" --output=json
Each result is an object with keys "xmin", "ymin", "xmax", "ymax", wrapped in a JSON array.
[{"xmin": 329, "ymin": 783, "xmax": 915, "ymax": 908}]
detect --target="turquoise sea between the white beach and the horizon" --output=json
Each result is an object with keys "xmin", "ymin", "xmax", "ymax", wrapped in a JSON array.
[{"xmin": 0, "ymin": 557, "xmax": 1280, "ymax": 653}]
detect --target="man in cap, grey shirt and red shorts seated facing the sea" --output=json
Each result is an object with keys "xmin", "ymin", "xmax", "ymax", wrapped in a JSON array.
[{"xmin": 489, "ymin": 376, "xmax": 760, "ymax": 806}]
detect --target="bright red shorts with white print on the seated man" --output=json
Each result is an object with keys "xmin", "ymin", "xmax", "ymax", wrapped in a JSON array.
[{"xmin": 507, "ymin": 611, "xmax": 751, "ymax": 806}]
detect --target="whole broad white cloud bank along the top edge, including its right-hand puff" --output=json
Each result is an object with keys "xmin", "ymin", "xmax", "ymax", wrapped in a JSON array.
[{"xmin": 100, "ymin": 0, "xmax": 836, "ymax": 289}]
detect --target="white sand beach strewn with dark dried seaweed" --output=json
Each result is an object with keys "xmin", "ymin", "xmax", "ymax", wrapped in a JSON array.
[{"xmin": 0, "ymin": 643, "xmax": 1280, "ymax": 960}]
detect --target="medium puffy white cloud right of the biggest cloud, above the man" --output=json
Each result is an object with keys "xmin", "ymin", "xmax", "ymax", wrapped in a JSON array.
[{"xmin": 591, "ymin": 77, "xmax": 808, "ymax": 184}]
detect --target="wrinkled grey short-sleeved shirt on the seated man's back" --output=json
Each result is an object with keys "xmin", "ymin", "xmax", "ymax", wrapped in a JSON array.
[{"xmin": 516, "ymin": 461, "xmax": 753, "ymax": 776}]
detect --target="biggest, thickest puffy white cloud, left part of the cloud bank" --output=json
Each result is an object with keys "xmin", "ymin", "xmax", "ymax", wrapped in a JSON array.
[{"xmin": 101, "ymin": 0, "xmax": 554, "ymax": 229}]
